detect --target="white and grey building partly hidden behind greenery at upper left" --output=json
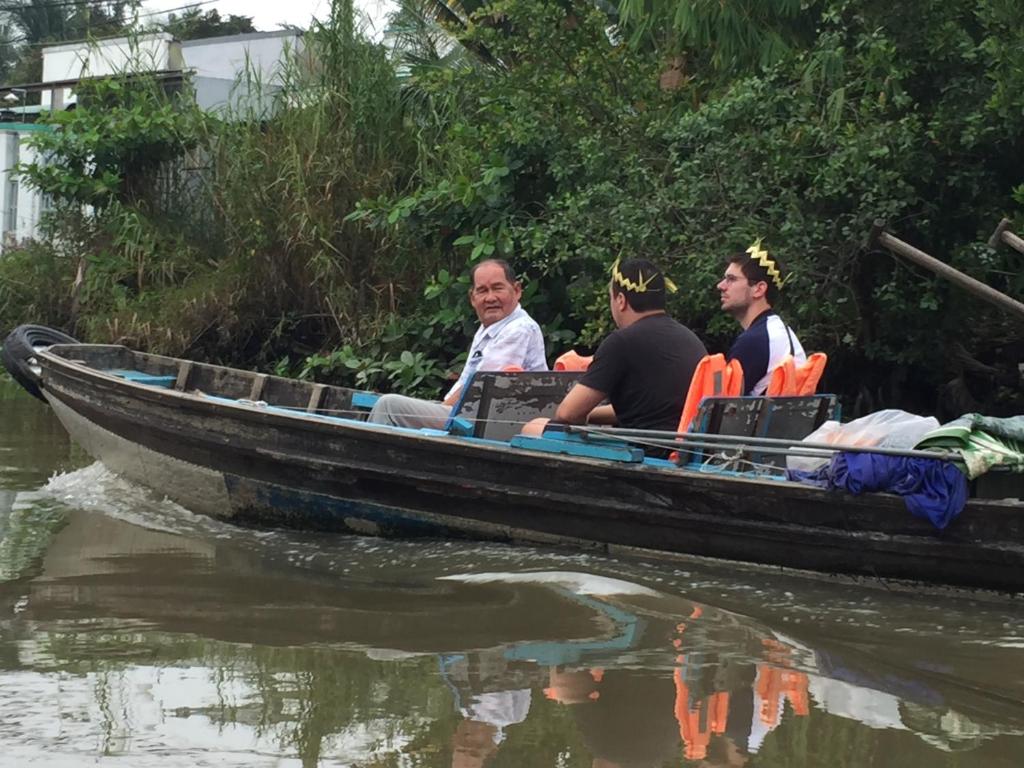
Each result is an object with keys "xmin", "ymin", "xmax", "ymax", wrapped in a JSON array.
[{"xmin": 0, "ymin": 30, "xmax": 303, "ymax": 249}]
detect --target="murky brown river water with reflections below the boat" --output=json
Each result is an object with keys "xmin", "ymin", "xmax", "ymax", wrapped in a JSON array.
[{"xmin": 0, "ymin": 382, "xmax": 1024, "ymax": 768}]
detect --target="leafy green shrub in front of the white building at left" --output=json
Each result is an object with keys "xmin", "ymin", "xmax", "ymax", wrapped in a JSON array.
[{"xmin": 17, "ymin": 78, "xmax": 206, "ymax": 336}]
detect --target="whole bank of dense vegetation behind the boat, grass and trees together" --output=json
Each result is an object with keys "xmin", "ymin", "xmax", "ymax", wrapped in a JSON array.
[{"xmin": 0, "ymin": 0, "xmax": 1024, "ymax": 415}]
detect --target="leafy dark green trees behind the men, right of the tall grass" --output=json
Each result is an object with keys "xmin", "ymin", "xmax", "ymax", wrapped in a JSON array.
[{"xmin": 357, "ymin": 0, "xmax": 1024, "ymax": 412}]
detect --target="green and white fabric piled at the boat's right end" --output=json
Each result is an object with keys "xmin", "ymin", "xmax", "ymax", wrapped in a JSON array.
[{"xmin": 914, "ymin": 414, "xmax": 1024, "ymax": 480}]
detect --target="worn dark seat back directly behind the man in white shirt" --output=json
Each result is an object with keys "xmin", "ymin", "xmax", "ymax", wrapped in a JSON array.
[{"xmin": 444, "ymin": 371, "xmax": 583, "ymax": 442}]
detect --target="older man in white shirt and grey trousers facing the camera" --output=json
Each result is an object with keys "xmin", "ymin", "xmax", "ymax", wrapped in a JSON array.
[{"xmin": 368, "ymin": 259, "xmax": 548, "ymax": 429}]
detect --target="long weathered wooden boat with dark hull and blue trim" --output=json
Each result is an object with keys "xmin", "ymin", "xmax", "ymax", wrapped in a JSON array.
[{"xmin": 2, "ymin": 331, "xmax": 1024, "ymax": 592}]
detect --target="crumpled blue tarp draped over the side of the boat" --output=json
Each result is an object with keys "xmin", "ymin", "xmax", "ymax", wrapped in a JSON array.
[{"xmin": 790, "ymin": 453, "xmax": 967, "ymax": 529}]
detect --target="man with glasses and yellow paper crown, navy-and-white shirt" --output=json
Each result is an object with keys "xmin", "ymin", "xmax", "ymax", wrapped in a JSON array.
[{"xmin": 718, "ymin": 240, "xmax": 807, "ymax": 395}]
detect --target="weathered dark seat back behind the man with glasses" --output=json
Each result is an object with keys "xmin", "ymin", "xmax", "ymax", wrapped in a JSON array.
[{"xmin": 689, "ymin": 394, "xmax": 839, "ymax": 470}]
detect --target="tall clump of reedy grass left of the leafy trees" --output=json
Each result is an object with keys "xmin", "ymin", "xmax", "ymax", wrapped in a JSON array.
[{"xmin": 203, "ymin": 0, "xmax": 427, "ymax": 360}]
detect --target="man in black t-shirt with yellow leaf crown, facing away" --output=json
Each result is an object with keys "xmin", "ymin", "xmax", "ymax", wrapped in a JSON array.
[{"xmin": 523, "ymin": 259, "xmax": 708, "ymax": 435}]
